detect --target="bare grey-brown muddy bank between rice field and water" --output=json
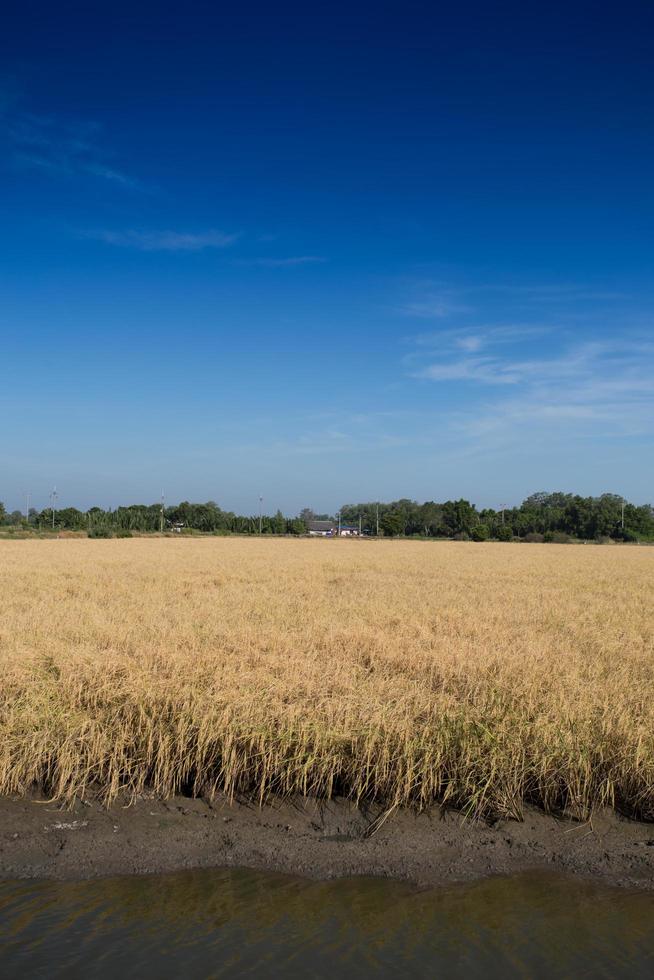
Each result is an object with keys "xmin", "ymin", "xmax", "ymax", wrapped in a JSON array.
[{"xmin": 0, "ymin": 797, "xmax": 654, "ymax": 888}]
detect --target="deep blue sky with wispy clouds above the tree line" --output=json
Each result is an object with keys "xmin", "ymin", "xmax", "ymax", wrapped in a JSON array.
[{"xmin": 0, "ymin": 2, "xmax": 654, "ymax": 513}]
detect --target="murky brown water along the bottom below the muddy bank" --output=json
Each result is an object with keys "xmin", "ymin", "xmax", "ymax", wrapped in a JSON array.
[{"xmin": 0, "ymin": 870, "xmax": 654, "ymax": 980}]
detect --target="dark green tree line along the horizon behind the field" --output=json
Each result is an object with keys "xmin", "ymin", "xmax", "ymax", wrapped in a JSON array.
[{"xmin": 0, "ymin": 492, "xmax": 654, "ymax": 541}]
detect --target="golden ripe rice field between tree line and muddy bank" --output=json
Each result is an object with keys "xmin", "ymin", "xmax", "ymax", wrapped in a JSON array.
[{"xmin": 0, "ymin": 538, "xmax": 654, "ymax": 818}]
